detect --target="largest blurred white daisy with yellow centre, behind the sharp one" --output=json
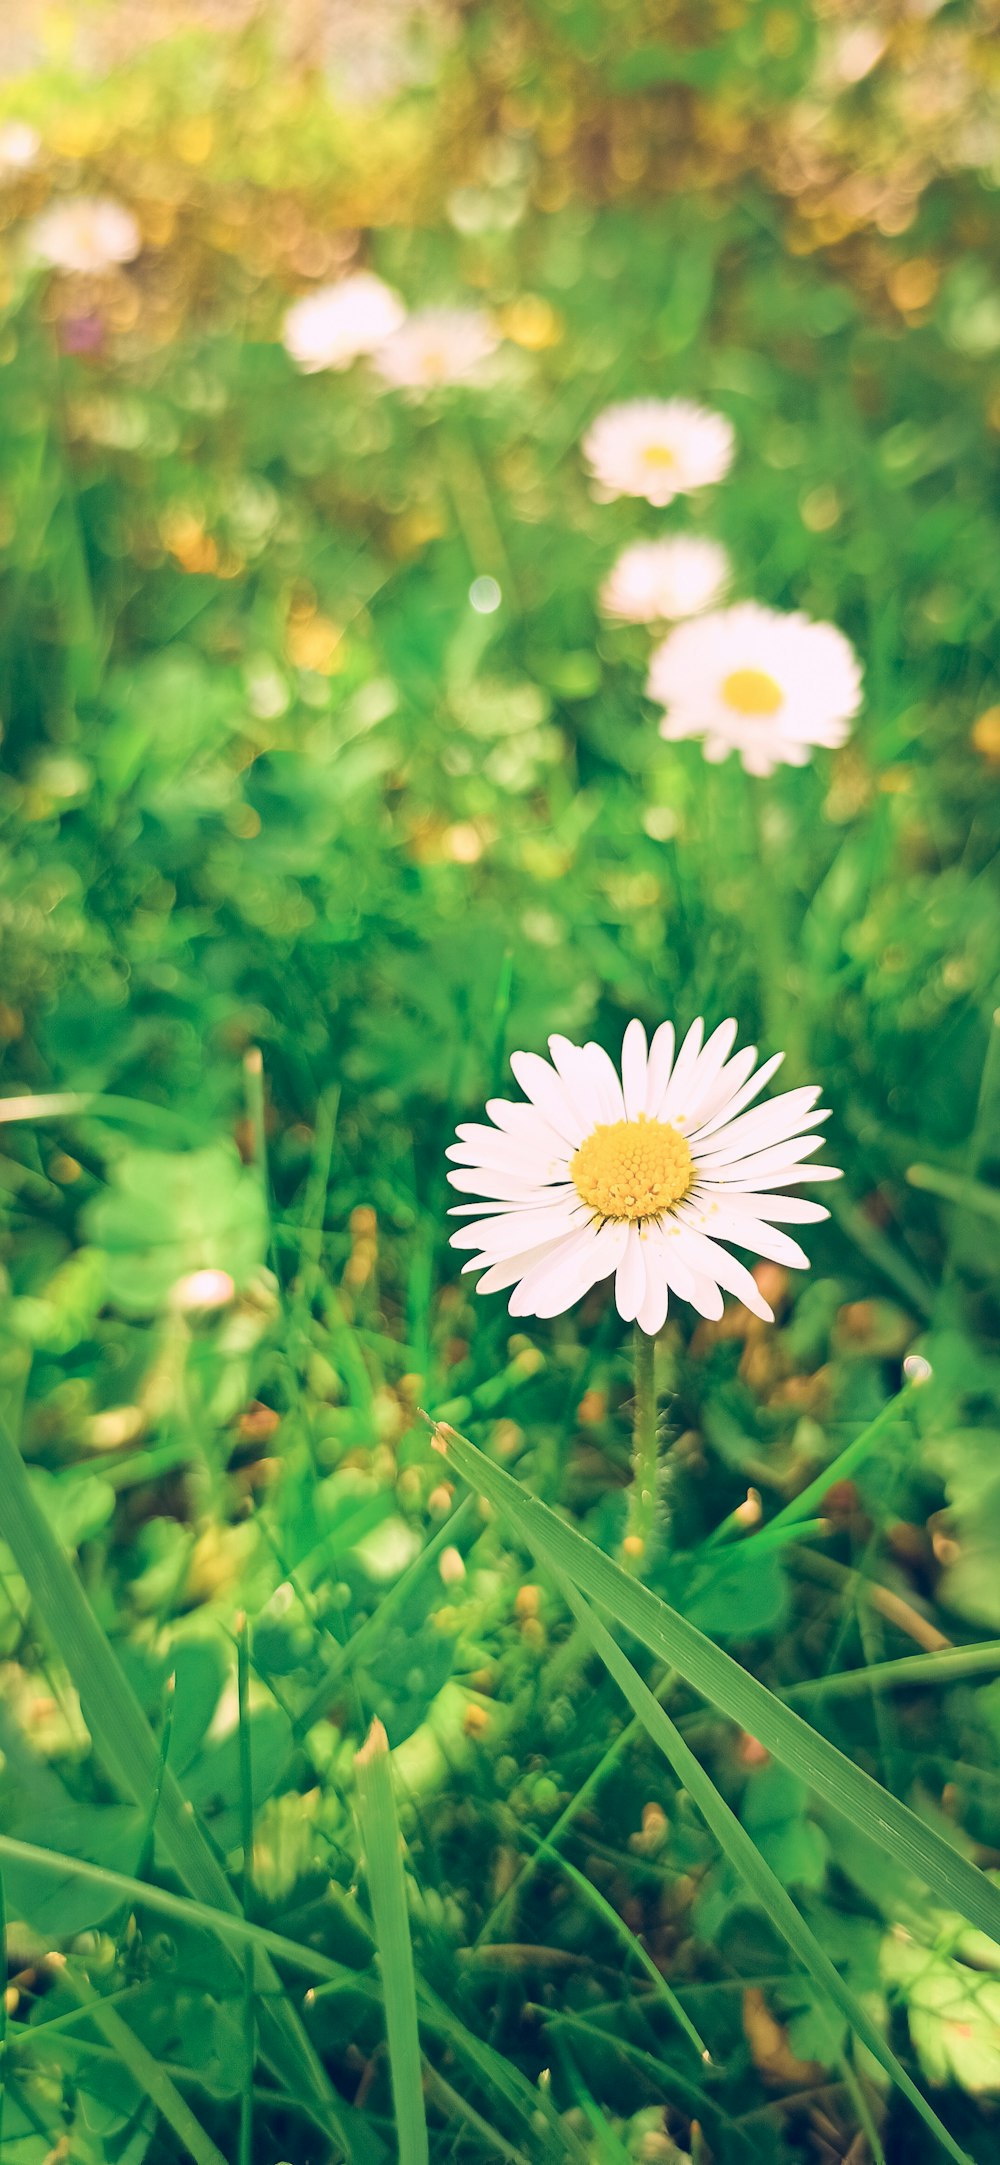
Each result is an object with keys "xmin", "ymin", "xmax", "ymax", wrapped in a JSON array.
[{"xmin": 647, "ymin": 602, "xmax": 861, "ymax": 775}]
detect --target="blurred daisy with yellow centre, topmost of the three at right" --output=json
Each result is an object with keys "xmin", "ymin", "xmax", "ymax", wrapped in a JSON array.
[{"xmin": 582, "ymin": 398, "xmax": 734, "ymax": 504}]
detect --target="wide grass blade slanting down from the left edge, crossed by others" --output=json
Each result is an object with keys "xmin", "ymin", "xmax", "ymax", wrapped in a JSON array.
[{"xmin": 0, "ymin": 1422, "xmax": 377, "ymax": 2165}]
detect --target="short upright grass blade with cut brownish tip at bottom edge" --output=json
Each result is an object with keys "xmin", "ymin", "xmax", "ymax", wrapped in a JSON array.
[{"xmin": 355, "ymin": 1721, "xmax": 429, "ymax": 2165}]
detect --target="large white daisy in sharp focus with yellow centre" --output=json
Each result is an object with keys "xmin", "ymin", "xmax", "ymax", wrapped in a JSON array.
[{"xmin": 448, "ymin": 1022, "xmax": 840, "ymax": 1336}]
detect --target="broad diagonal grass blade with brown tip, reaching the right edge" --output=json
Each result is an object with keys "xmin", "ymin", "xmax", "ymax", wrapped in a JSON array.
[{"xmin": 435, "ymin": 1425, "xmax": 1000, "ymax": 1944}]
